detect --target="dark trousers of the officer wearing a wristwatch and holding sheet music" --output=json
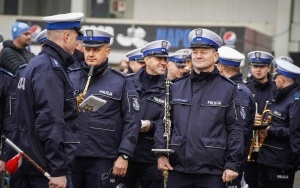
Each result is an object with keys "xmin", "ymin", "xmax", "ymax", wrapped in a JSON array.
[{"xmin": 72, "ymin": 157, "xmax": 116, "ymax": 188}]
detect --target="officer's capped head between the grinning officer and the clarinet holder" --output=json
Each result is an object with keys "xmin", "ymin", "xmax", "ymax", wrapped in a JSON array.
[{"xmin": 167, "ymin": 53, "xmax": 188, "ymax": 82}]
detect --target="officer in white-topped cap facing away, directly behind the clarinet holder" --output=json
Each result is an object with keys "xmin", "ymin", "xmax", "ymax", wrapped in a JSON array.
[{"xmin": 217, "ymin": 46, "xmax": 255, "ymax": 188}]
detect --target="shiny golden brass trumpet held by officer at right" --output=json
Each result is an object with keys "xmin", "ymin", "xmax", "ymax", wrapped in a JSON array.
[{"xmin": 247, "ymin": 101, "xmax": 272, "ymax": 162}]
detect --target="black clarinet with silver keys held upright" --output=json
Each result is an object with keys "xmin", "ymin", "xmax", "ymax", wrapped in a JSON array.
[{"xmin": 151, "ymin": 78, "xmax": 174, "ymax": 155}]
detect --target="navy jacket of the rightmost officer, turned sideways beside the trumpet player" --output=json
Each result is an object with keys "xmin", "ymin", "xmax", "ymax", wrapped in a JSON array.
[{"xmin": 257, "ymin": 84, "xmax": 300, "ymax": 169}]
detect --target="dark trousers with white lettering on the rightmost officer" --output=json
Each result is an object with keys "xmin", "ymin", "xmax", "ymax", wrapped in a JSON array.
[{"xmin": 258, "ymin": 164, "xmax": 295, "ymax": 188}]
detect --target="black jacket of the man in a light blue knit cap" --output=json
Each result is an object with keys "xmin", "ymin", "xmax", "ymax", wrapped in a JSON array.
[{"xmin": 0, "ymin": 40, "xmax": 35, "ymax": 74}]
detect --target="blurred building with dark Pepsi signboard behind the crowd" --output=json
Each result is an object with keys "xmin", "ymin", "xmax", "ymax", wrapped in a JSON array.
[{"xmin": 0, "ymin": 0, "xmax": 300, "ymax": 70}]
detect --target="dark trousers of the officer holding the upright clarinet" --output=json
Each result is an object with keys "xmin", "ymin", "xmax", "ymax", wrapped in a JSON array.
[{"xmin": 167, "ymin": 171, "xmax": 226, "ymax": 188}]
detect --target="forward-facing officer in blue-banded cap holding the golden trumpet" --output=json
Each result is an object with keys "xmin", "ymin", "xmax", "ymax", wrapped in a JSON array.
[{"xmin": 244, "ymin": 51, "xmax": 275, "ymax": 188}]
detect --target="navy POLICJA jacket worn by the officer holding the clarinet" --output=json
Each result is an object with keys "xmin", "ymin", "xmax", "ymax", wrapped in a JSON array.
[{"xmin": 155, "ymin": 73, "xmax": 244, "ymax": 175}]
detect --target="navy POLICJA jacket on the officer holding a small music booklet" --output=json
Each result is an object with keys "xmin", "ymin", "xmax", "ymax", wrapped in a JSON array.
[{"xmin": 68, "ymin": 61, "xmax": 140, "ymax": 159}]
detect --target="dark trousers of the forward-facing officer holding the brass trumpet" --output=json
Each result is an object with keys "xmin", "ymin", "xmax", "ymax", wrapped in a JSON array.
[{"xmin": 244, "ymin": 162, "xmax": 258, "ymax": 188}]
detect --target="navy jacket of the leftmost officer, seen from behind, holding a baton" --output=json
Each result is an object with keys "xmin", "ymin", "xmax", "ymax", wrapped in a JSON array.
[{"xmin": 13, "ymin": 40, "xmax": 79, "ymax": 177}]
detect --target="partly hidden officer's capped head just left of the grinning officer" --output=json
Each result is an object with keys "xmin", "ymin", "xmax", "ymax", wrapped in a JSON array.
[{"xmin": 126, "ymin": 48, "xmax": 145, "ymax": 73}]
